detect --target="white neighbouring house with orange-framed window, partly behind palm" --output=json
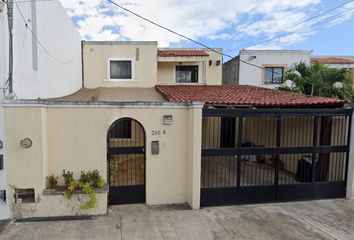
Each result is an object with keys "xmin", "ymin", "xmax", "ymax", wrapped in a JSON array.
[{"xmin": 223, "ymin": 50, "xmax": 312, "ymax": 88}]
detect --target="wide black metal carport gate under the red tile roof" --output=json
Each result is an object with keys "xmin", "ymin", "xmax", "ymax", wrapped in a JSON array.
[{"xmin": 201, "ymin": 108, "xmax": 353, "ymax": 206}]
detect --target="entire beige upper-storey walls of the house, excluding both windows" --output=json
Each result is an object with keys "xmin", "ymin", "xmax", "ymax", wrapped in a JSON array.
[{"xmin": 83, "ymin": 41, "xmax": 222, "ymax": 89}]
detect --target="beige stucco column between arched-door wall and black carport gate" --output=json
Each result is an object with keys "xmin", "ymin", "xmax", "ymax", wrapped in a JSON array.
[{"xmin": 188, "ymin": 105, "xmax": 202, "ymax": 209}]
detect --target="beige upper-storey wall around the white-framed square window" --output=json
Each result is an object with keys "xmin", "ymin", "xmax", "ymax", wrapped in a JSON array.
[{"xmin": 83, "ymin": 42, "xmax": 157, "ymax": 88}]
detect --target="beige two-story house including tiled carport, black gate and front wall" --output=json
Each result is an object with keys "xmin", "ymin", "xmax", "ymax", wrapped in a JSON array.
[{"xmin": 4, "ymin": 41, "xmax": 353, "ymax": 218}]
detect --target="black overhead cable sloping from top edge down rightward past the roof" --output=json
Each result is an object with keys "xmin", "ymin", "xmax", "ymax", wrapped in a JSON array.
[{"xmin": 107, "ymin": 0, "xmax": 280, "ymax": 76}]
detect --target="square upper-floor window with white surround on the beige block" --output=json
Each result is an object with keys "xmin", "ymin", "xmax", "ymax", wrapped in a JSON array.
[{"xmin": 109, "ymin": 60, "xmax": 132, "ymax": 79}]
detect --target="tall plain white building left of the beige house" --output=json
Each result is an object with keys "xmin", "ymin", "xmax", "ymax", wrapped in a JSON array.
[{"xmin": 0, "ymin": 0, "xmax": 82, "ymax": 219}]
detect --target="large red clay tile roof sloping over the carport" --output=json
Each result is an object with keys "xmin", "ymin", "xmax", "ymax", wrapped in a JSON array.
[{"xmin": 156, "ymin": 85, "xmax": 345, "ymax": 107}]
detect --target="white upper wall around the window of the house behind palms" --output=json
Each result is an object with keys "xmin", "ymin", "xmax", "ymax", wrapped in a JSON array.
[{"xmin": 239, "ymin": 50, "xmax": 311, "ymax": 88}]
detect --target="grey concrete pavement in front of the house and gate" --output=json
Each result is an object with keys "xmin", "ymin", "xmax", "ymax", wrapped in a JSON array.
[{"xmin": 0, "ymin": 199, "xmax": 354, "ymax": 240}]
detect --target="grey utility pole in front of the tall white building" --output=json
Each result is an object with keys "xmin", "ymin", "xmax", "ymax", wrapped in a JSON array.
[{"xmin": 6, "ymin": 0, "xmax": 14, "ymax": 94}]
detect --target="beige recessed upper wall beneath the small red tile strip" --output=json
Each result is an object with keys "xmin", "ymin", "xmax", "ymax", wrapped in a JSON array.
[{"xmin": 157, "ymin": 49, "xmax": 222, "ymax": 85}]
